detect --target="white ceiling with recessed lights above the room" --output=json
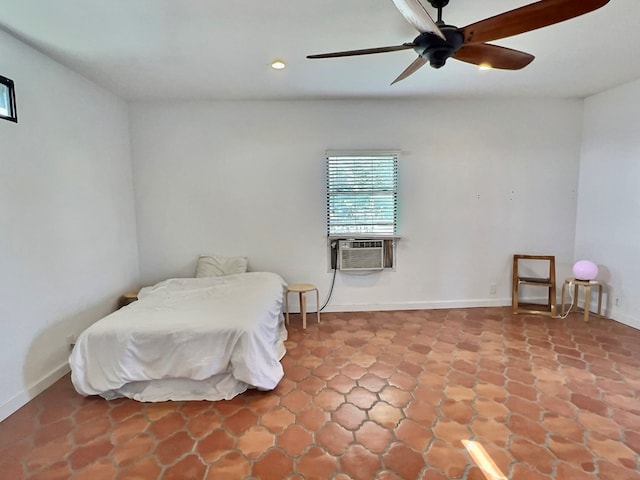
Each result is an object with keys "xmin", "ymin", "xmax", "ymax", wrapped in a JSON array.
[{"xmin": 0, "ymin": 0, "xmax": 640, "ymax": 99}]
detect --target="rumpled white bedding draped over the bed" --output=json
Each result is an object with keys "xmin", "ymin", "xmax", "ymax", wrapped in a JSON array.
[{"xmin": 69, "ymin": 272, "xmax": 287, "ymax": 402}]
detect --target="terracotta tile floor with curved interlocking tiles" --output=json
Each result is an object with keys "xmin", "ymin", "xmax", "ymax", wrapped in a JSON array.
[{"xmin": 0, "ymin": 308, "xmax": 640, "ymax": 480}]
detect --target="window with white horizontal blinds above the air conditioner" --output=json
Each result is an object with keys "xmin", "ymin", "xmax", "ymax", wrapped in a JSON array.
[{"xmin": 327, "ymin": 153, "xmax": 398, "ymax": 236}]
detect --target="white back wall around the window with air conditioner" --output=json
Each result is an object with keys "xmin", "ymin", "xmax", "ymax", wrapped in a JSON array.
[{"xmin": 131, "ymin": 99, "xmax": 582, "ymax": 310}]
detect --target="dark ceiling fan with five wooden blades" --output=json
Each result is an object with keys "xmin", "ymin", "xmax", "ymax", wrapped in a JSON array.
[{"xmin": 307, "ymin": 0, "xmax": 609, "ymax": 85}]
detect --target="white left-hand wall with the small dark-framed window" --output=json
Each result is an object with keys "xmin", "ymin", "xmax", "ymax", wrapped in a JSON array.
[{"xmin": 0, "ymin": 31, "xmax": 138, "ymax": 419}]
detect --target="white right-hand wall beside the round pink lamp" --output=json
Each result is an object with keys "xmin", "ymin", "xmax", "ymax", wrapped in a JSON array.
[{"xmin": 575, "ymin": 81, "xmax": 640, "ymax": 328}]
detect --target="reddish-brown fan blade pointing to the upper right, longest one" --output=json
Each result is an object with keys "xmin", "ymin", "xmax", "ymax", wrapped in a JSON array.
[{"xmin": 462, "ymin": 0, "xmax": 609, "ymax": 44}]
